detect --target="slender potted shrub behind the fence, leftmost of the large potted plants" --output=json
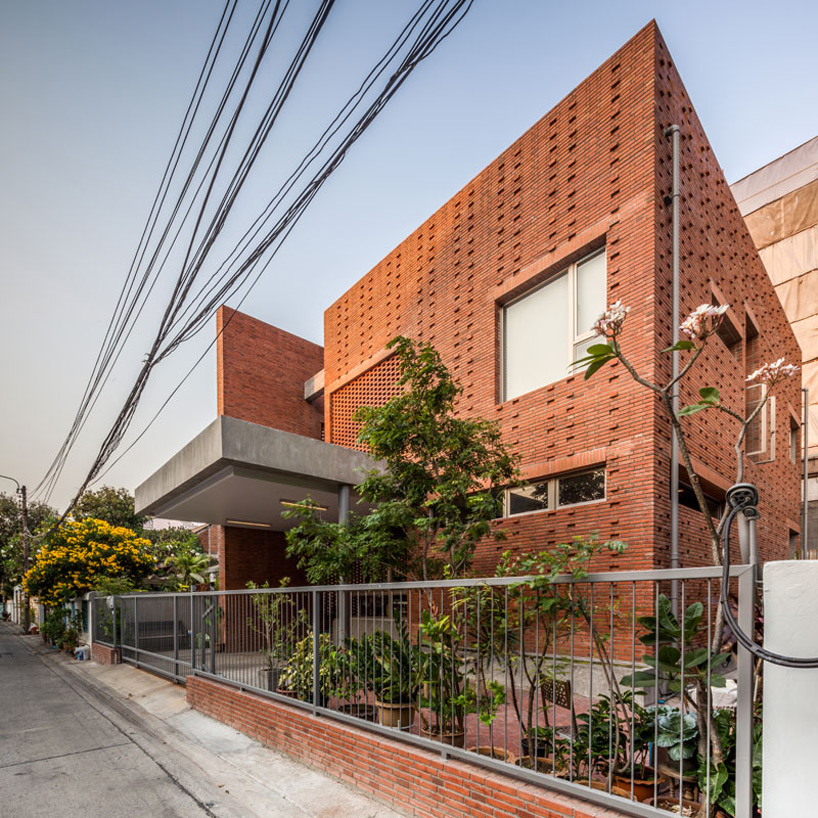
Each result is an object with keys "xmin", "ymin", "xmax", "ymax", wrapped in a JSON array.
[{"xmin": 247, "ymin": 577, "xmax": 307, "ymax": 691}]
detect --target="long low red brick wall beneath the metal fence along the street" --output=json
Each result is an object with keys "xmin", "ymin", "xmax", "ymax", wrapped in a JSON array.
[{"xmin": 187, "ymin": 676, "xmax": 621, "ymax": 818}]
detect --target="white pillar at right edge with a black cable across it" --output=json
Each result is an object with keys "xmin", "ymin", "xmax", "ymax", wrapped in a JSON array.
[{"xmin": 762, "ymin": 560, "xmax": 818, "ymax": 818}]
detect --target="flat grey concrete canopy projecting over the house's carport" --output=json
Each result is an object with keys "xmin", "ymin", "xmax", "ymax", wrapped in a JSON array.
[{"xmin": 135, "ymin": 415, "xmax": 378, "ymax": 531}]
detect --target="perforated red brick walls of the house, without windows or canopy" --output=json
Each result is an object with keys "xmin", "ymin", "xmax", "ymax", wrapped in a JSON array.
[{"xmin": 210, "ymin": 23, "xmax": 800, "ymax": 576}]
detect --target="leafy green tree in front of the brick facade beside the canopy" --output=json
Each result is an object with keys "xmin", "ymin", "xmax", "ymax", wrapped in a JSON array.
[{"xmin": 287, "ymin": 336, "xmax": 517, "ymax": 579}]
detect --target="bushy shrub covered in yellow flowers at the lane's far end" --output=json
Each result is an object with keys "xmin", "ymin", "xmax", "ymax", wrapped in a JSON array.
[{"xmin": 23, "ymin": 518, "xmax": 155, "ymax": 605}]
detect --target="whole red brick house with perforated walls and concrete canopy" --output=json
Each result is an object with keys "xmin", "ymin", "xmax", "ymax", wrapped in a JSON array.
[{"xmin": 136, "ymin": 23, "xmax": 801, "ymax": 590}]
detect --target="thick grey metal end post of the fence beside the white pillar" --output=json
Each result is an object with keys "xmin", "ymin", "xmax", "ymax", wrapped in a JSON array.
[{"xmin": 724, "ymin": 570, "xmax": 755, "ymax": 818}]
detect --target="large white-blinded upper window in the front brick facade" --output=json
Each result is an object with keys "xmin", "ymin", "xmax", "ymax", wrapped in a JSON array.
[{"xmin": 503, "ymin": 250, "xmax": 607, "ymax": 400}]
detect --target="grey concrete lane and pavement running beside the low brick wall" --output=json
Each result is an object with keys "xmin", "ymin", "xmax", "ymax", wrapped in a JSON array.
[{"xmin": 0, "ymin": 625, "xmax": 401, "ymax": 818}]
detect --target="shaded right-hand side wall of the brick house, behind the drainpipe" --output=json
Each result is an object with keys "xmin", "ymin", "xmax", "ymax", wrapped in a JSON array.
[{"xmin": 654, "ymin": 31, "xmax": 800, "ymax": 565}]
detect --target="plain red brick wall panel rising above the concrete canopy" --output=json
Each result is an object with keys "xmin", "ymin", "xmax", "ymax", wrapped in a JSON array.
[{"xmin": 216, "ymin": 307, "xmax": 324, "ymax": 439}]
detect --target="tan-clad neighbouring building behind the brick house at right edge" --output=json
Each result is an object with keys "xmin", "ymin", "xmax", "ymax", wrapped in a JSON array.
[{"xmin": 732, "ymin": 136, "xmax": 818, "ymax": 555}]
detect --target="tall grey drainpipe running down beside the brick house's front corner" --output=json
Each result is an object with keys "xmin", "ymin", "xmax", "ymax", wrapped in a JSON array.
[{"xmin": 665, "ymin": 125, "xmax": 680, "ymax": 614}]
